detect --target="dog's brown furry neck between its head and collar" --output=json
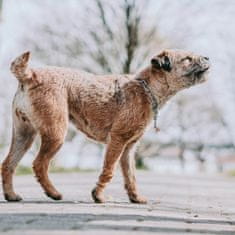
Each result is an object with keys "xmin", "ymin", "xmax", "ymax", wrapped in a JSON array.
[{"xmin": 137, "ymin": 67, "xmax": 176, "ymax": 108}]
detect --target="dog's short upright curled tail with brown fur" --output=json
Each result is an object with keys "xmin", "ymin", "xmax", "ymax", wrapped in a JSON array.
[{"xmin": 11, "ymin": 51, "xmax": 32, "ymax": 83}]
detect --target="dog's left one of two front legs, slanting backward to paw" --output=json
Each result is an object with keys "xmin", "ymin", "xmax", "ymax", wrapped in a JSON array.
[{"xmin": 92, "ymin": 137, "xmax": 126, "ymax": 203}]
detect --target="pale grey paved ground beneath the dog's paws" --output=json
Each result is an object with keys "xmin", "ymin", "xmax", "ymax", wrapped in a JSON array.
[{"xmin": 0, "ymin": 171, "xmax": 235, "ymax": 235}]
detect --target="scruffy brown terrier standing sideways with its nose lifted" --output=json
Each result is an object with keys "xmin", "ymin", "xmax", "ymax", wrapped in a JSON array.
[{"xmin": 2, "ymin": 50, "xmax": 209, "ymax": 203}]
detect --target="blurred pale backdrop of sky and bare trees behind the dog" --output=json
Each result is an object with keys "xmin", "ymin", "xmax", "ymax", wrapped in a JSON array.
[{"xmin": 0, "ymin": 0, "xmax": 235, "ymax": 173}]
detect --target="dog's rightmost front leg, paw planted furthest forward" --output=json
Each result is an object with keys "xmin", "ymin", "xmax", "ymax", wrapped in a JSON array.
[{"xmin": 120, "ymin": 142, "xmax": 147, "ymax": 203}]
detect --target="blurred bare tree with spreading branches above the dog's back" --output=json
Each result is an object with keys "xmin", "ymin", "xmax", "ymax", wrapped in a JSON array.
[{"xmin": 23, "ymin": 0, "xmax": 167, "ymax": 73}]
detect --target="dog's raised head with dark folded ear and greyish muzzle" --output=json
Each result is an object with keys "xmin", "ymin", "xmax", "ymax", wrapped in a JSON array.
[{"xmin": 151, "ymin": 50, "xmax": 210, "ymax": 91}]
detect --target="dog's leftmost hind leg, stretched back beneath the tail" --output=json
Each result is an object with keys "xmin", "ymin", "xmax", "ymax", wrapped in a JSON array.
[{"xmin": 2, "ymin": 114, "xmax": 36, "ymax": 201}]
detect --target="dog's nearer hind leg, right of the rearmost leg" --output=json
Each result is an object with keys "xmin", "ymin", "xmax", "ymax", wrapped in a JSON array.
[{"xmin": 33, "ymin": 117, "xmax": 68, "ymax": 200}]
